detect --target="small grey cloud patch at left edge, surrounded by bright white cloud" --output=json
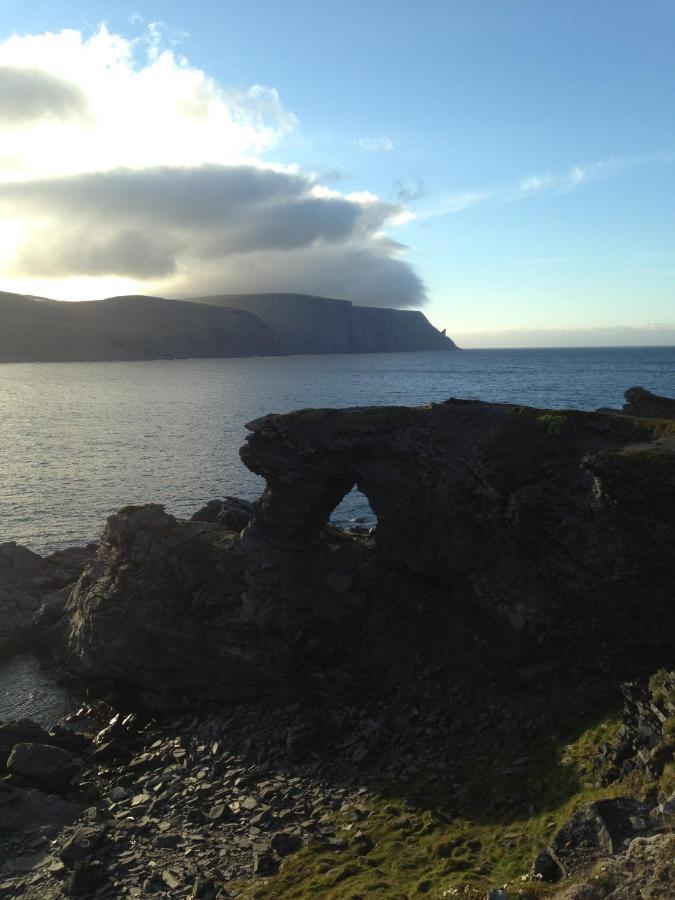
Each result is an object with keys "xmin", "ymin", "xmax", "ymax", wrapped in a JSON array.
[{"xmin": 0, "ymin": 66, "xmax": 87, "ymax": 126}]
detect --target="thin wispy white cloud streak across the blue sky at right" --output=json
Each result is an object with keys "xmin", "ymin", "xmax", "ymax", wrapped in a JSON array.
[{"xmin": 426, "ymin": 152, "xmax": 675, "ymax": 219}]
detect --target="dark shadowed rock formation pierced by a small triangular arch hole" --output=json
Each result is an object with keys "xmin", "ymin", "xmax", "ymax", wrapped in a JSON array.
[{"xmin": 66, "ymin": 400, "xmax": 675, "ymax": 705}]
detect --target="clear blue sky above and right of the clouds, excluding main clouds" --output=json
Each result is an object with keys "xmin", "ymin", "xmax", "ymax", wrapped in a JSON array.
[{"xmin": 0, "ymin": 0, "xmax": 675, "ymax": 346}]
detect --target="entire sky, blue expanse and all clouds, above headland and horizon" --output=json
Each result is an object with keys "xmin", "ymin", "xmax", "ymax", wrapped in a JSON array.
[{"xmin": 0, "ymin": 0, "xmax": 675, "ymax": 347}]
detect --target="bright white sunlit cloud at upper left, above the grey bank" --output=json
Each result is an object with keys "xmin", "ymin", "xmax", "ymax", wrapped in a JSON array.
[{"xmin": 0, "ymin": 26, "xmax": 295, "ymax": 180}]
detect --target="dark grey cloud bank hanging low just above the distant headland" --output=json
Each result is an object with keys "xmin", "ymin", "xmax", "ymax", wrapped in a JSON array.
[{"xmin": 0, "ymin": 165, "xmax": 425, "ymax": 307}]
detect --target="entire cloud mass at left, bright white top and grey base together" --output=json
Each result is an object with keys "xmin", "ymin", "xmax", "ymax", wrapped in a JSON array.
[{"xmin": 0, "ymin": 24, "xmax": 426, "ymax": 306}]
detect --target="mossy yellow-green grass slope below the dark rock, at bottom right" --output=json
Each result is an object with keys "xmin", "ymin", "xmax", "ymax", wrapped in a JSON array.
[{"xmin": 233, "ymin": 695, "xmax": 635, "ymax": 900}]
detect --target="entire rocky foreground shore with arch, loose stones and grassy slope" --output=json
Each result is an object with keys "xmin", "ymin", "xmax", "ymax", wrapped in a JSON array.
[{"xmin": 0, "ymin": 388, "xmax": 675, "ymax": 900}]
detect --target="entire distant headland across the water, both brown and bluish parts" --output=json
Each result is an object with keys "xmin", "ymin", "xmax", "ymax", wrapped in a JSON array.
[{"xmin": 0, "ymin": 291, "xmax": 456, "ymax": 362}]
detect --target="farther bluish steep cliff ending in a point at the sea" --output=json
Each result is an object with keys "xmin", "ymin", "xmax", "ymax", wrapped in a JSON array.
[{"xmin": 189, "ymin": 294, "xmax": 457, "ymax": 353}]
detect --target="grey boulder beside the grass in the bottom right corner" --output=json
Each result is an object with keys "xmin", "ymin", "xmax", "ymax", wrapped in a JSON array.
[{"xmin": 549, "ymin": 797, "xmax": 649, "ymax": 876}]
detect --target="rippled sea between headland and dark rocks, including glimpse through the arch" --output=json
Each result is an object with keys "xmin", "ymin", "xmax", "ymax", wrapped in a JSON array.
[{"xmin": 0, "ymin": 347, "xmax": 675, "ymax": 553}]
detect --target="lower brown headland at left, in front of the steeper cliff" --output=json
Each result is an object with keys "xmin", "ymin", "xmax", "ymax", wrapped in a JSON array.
[{"xmin": 0, "ymin": 293, "xmax": 281, "ymax": 362}]
